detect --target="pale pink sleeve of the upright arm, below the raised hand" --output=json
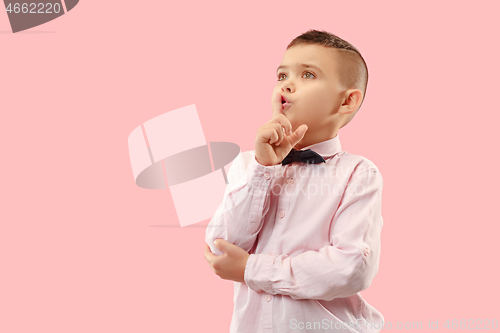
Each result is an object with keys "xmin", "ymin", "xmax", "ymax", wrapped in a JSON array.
[{"xmin": 205, "ymin": 151, "xmax": 276, "ymax": 255}]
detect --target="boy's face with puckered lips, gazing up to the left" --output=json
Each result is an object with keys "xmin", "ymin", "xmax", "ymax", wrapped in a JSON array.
[{"xmin": 274, "ymin": 44, "xmax": 345, "ymax": 147}]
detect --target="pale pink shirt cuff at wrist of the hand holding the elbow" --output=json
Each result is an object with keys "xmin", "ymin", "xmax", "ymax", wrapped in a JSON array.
[{"xmin": 243, "ymin": 253, "xmax": 275, "ymax": 295}]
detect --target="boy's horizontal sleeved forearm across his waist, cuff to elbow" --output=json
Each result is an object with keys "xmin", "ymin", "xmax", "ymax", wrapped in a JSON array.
[{"xmin": 245, "ymin": 241, "xmax": 378, "ymax": 301}]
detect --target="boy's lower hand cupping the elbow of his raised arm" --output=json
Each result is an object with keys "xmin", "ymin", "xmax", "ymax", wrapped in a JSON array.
[{"xmin": 205, "ymin": 239, "xmax": 250, "ymax": 283}]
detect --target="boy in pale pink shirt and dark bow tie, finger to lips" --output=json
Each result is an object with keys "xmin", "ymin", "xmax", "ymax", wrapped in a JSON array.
[{"xmin": 205, "ymin": 30, "xmax": 384, "ymax": 333}]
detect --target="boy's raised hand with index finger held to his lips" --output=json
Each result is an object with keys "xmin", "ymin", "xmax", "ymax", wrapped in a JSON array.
[{"xmin": 255, "ymin": 89, "xmax": 307, "ymax": 166}]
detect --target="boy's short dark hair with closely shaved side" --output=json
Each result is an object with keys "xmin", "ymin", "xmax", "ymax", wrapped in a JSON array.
[{"xmin": 286, "ymin": 30, "xmax": 368, "ymax": 128}]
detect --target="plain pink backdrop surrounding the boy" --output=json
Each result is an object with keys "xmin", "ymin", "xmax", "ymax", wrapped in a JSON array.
[{"xmin": 0, "ymin": 0, "xmax": 500, "ymax": 333}]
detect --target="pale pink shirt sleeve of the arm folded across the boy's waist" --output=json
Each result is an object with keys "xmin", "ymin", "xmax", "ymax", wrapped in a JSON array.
[{"xmin": 244, "ymin": 168, "xmax": 383, "ymax": 301}]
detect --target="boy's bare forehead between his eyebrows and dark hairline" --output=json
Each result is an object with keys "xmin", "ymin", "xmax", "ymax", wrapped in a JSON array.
[{"xmin": 280, "ymin": 44, "xmax": 336, "ymax": 73}]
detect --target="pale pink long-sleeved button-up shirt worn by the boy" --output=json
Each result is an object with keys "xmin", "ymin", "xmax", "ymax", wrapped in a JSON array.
[{"xmin": 205, "ymin": 134, "xmax": 384, "ymax": 333}]
